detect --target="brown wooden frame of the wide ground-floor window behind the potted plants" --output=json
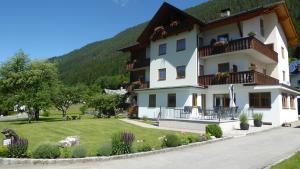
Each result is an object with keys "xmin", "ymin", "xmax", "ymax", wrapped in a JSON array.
[{"xmin": 249, "ymin": 92, "xmax": 272, "ymax": 109}]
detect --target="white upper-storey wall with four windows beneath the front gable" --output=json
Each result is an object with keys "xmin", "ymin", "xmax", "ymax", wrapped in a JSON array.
[{"xmin": 150, "ymin": 27, "xmax": 198, "ymax": 88}]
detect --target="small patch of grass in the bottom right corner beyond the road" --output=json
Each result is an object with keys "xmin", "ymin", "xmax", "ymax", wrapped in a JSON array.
[{"xmin": 271, "ymin": 152, "xmax": 300, "ymax": 169}]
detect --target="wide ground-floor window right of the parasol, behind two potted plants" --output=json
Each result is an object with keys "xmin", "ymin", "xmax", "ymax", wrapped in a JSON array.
[{"xmin": 249, "ymin": 92, "xmax": 271, "ymax": 108}]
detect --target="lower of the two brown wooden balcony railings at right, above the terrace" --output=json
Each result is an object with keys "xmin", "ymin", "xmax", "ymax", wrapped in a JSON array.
[{"xmin": 198, "ymin": 70, "xmax": 279, "ymax": 86}]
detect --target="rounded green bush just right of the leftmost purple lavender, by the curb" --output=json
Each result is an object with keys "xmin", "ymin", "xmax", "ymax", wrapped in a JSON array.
[{"xmin": 32, "ymin": 143, "xmax": 60, "ymax": 159}]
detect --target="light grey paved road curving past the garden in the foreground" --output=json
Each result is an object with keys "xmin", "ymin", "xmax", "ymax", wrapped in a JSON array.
[{"xmin": 0, "ymin": 125, "xmax": 300, "ymax": 169}]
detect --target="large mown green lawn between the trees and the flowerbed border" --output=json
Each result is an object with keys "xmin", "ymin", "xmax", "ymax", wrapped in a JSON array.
[{"xmin": 0, "ymin": 106, "xmax": 195, "ymax": 156}]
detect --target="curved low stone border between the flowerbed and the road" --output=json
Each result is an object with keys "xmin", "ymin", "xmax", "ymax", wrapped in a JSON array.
[{"xmin": 0, "ymin": 137, "xmax": 234, "ymax": 165}]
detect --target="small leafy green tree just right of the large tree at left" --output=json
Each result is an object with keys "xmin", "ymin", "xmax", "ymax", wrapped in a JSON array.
[{"xmin": 52, "ymin": 84, "xmax": 84, "ymax": 119}]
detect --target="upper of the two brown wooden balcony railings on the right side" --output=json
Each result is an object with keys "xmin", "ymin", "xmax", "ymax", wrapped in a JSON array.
[{"xmin": 199, "ymin": 37, "xmax": 278, "ymax": 62}]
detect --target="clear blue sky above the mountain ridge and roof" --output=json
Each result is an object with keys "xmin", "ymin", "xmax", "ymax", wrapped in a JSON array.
[{"xmin": 0, "ymin": 0, "xmax": 204, "ymax": 62}]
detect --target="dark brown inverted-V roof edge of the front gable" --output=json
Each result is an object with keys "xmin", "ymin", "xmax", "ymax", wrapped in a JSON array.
[{"xmin": 137, "ymin": 2, "xmax": 205, "ymax": 43}]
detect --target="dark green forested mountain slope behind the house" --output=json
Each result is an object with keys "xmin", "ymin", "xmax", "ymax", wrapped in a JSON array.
[{"xmin": 50, "ymin": 0, "xmax": 300, "ymax": 84}]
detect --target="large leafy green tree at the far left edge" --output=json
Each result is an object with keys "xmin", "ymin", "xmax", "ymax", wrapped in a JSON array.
[{"xmin": 0, "ymin": 51, "xmax": 58, "ymax": 122}]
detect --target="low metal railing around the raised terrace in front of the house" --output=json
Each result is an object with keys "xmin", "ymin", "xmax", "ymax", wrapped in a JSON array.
[{"xmin": 157, "ymin": 106, "xmax": 253, "ymax": 121}]
